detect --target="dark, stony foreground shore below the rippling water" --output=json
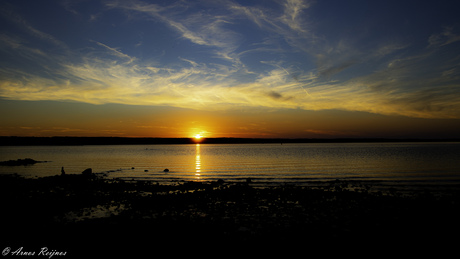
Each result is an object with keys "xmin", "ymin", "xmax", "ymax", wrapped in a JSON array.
[{"xmin": 0, "ymin": 175, "xmax": 460, "ymax": 258}]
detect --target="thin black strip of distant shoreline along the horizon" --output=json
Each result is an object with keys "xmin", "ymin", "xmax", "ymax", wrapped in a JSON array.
[{"xmin": 0, "ymin": 136, "xmax": 460, "ymax": 146}]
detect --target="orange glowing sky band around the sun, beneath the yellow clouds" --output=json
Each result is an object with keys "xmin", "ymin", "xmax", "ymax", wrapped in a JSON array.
[{"xmin": 0, "ymin": 101, "xmax": 459, "ymax": 140}]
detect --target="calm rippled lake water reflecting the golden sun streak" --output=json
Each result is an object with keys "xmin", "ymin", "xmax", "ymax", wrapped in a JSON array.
[{"xmin": 0, "ymin": 143, "xmax": 460, "ymax": 188}]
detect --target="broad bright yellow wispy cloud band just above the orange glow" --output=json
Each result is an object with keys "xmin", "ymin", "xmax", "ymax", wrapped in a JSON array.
[{"xmin": 0, "ymin": 38, "xmax": 460, "ymax": 118}]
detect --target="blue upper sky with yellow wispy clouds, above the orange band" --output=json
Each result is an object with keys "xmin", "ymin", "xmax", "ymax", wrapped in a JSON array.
[{"xmin": 0, "ymin": 0, "xmax": 460, "ymax": 138}]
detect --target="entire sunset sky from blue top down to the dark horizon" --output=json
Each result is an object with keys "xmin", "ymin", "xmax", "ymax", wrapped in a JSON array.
[{"xmin": 0, "ymin": 0, "xmax": 460, "ymax": 138}]
